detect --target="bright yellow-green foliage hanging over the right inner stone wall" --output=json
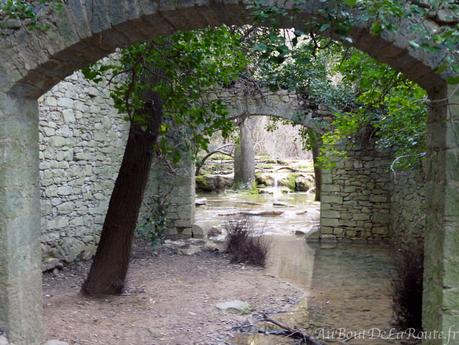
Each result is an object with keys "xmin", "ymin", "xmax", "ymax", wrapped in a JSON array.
[{"xmin": 320, "ymin": 50, "xmax": 428, "ymax": 168}]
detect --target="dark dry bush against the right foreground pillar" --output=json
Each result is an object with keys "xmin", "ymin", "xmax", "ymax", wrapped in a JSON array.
[{"xmin": 392, "ymin": 245, "xmax": 424, "ymax": 331}]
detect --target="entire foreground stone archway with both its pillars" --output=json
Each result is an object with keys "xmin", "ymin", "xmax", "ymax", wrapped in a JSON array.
[{"xmin": 0, "ymin": 0, "xmax": 459, "ymax": 345}]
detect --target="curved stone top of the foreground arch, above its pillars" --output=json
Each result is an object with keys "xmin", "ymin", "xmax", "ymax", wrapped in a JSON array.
[{"xmin": 0, "ymin": 0, "xmax": 450, "ymax": 98}]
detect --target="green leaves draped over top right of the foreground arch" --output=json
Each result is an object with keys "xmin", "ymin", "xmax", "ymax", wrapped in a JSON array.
[{"xmin": 250, "ymin": 0, "xmax": 459, "ymax": 78}]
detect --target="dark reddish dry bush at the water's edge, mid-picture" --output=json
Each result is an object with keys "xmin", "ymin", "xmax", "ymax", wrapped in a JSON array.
[{"xmin": 225, "ymin": 218, "xmax": 270, "ymax": 267}]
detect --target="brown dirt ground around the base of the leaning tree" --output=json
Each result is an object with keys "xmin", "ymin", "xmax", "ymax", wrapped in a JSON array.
[{"xmin": 44, "ymin": 245, "xmax": 304, "ymax": 345}]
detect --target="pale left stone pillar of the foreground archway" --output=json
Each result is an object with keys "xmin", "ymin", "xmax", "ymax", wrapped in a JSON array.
[{"xmin": 0, "ymin": 94, "xmax": 43, "ymax": 345}]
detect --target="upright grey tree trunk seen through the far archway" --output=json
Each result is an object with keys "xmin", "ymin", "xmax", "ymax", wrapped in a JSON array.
[{"xmin": 234, "ymin": 119, "xmax": 255, "ymax": 188}]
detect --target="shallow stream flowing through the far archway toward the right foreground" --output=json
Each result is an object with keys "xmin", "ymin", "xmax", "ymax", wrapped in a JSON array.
[{"xmin": 196, "ymin": 192, "xmax": 405, "ymax": 345}]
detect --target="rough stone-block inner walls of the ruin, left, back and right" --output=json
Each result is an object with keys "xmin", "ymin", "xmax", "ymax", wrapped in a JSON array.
[{"xmin": 40, "ymin": 73, "xmax": 424, "ymax": 267}]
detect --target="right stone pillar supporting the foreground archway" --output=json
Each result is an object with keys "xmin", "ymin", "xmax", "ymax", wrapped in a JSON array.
[{"xmin": 423, "ymin": 87, "xmax": 459, "ymax": 345}]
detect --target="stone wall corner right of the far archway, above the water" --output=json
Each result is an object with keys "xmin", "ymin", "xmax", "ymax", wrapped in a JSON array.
[{"xmin": 316, "ymin": 146, "xmax": 427, "ymax": 248}]
